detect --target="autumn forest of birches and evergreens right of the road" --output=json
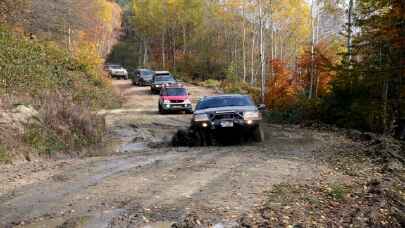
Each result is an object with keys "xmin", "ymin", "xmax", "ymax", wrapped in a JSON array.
[{"xmin": 109, "ymin": 0, "xmax": 405, "ymax": 136}]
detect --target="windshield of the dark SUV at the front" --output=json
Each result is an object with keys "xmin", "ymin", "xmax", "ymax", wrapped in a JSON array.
[{"xmin": 196, "ymin": 96, "xmax": 254, "ymax": 110}]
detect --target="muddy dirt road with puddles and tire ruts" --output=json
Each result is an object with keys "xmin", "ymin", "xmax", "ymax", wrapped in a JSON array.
[{"xmin": 0, "ymin": 81, "xmax": 348, "ymax": 227}]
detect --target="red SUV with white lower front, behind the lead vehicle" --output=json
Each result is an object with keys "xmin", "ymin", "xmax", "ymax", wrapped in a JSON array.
[{"xmin": 159, "ymin": 84, "xmax": 193, "ymax": 114}]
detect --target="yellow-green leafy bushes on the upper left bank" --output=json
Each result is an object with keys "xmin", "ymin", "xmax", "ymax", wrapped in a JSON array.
[{"xmin": 0, "ymin": 27, "xmax": 118, "ymax": 108}]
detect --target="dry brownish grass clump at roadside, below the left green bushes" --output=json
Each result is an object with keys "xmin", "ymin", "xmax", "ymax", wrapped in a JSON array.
[{"xmin": 23, "ymin": 94, "xmax": 105, "ymax": 155}]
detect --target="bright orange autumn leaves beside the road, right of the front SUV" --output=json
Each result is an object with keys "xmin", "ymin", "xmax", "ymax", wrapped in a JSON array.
[{"xmin": 266, "ymin": 38, "xmax": 340, "ymax": 111}]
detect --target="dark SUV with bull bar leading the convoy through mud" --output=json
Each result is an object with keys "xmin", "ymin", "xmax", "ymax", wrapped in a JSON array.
[{"xmin": 185, "ymin": 94, "xmax": 264, "ymax": 145}]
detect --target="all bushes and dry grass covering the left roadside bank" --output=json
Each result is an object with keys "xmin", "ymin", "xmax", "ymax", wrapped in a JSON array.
[{"xmin": 0, "ymin": 26, "xmax": 120, "ymax": 160}]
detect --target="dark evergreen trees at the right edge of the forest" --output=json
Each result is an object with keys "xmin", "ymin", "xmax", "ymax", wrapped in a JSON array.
[{"xmin": 322, "ymin": 0, "xmax": 405, "ymax": 132}]
